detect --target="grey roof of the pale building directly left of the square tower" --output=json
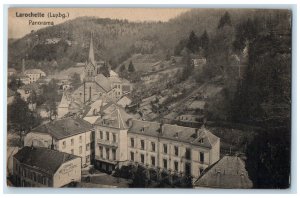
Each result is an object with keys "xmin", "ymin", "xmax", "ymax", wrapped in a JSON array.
[{"xmin": 32, "ymin": 117, "xmax": 93, "ymax": 140}]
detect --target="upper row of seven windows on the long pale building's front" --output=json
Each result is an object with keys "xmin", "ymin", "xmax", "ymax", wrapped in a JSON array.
[{"xmin": 130, "ymin": 138, "xmax": 204, "ymax": 163}]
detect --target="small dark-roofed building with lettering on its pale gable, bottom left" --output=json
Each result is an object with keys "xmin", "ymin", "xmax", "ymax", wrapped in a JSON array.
[{"xmin": 13, "ymin": 146, "xmax": 81, "ymax": 188}]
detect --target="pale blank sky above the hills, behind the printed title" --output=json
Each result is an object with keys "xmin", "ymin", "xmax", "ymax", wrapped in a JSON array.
[{"xmin": 8, "ymin": 8, "xmax": 189, "ymax": 38}]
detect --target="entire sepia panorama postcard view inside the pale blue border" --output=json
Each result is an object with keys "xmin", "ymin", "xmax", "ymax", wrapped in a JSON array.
[{"xmin": 3, "ymin": 6, "xmax": 294, "ymax": 189}]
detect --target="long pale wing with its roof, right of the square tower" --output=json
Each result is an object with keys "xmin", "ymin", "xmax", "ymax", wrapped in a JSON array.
[{"xmin": 127, "ymin": 120, "xmax": 220, "ymax": 178}]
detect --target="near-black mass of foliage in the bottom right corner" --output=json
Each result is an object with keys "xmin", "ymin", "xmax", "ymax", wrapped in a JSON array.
[{"xmin": 246, "ymin": 126, "xmax": 291, "ymax": 189}]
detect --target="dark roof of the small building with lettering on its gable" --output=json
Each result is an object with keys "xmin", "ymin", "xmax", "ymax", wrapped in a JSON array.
[{"xmin": 14, "ymin": 146, "xmax": 79, "ymax": 175}]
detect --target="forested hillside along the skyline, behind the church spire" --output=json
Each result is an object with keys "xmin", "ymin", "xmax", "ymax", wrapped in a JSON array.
[{"xmin": 8, "ymin": 9, "xmax": 284, "ymax": 73}]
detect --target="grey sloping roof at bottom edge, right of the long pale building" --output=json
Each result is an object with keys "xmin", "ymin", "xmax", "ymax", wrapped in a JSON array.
[{"xmin": 195, "ymin": 156, "xmax": 253, "ymax": 189}]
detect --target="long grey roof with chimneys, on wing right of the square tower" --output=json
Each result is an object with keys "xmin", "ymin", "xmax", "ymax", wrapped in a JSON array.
[{"xmin": 128, "ymin": 120, "xmax": 219, "ymax": 148}]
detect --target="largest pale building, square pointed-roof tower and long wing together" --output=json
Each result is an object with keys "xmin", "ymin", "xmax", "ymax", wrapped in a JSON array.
[{"xmin": 95, "ymin": 105, "xmax": 220, "ymax": 178}]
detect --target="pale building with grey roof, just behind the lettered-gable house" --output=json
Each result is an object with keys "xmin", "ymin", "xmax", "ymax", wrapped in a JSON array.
[{"xmin": 24, "ymin": 117, "xmax": 94, "ymax": 167}]
